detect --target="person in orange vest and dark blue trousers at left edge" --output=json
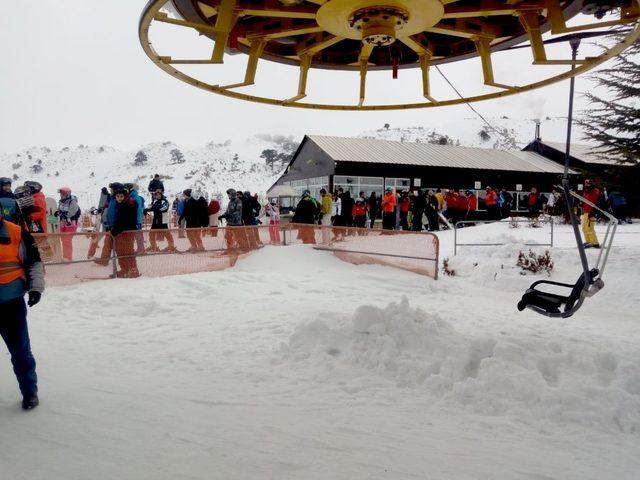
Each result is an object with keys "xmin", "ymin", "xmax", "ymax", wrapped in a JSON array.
[{"xmin": 0, "ymin": 212, "xmax": 44, "ymax": 410}]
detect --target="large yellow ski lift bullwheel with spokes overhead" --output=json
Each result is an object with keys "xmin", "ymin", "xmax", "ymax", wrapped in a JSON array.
[{"xmin": 139, "ymin": 0, "xmax": 640, "ymax": 110}]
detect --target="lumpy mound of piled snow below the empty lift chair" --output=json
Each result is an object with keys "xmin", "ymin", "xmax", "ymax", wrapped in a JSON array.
[{"xmin": 280, "ymin": 297, "xmax": 640, "ymax": 436}]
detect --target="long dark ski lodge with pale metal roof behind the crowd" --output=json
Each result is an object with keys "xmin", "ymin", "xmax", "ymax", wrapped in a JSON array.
[{"xmin": 268, "ymin": 135, "xmax": 575, "ymax": 210}]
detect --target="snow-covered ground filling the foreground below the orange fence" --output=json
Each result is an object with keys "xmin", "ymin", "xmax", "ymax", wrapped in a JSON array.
[{"xmin": 0, "ymin": 224, "xmax": 640, "ymax": 480}]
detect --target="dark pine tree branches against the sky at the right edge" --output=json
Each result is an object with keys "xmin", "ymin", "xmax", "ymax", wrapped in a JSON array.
[{"xmin": 578, "ymin": 37, "xmax": 640, "ymax": 165}]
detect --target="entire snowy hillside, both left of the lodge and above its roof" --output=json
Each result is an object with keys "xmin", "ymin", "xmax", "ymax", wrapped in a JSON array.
[{"xmin": 0, "ymin": 117, "xmax": 580, "ymax": 208}]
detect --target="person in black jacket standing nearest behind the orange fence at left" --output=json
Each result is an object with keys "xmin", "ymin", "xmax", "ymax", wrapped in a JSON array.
[{"xmin": 111, "ymin": 188, "xmax": 140, "ymax": 278}]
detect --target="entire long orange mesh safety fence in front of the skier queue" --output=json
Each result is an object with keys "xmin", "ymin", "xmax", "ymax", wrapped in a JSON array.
[{"xmin": 34, "ymin": 224, "xmax": 438, "ymax": 285}]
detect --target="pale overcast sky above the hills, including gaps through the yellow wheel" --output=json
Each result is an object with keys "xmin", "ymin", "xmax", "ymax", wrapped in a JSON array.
[{"xmin": 0, "ymin": 0, "xmax": 608, "ymax": 152}]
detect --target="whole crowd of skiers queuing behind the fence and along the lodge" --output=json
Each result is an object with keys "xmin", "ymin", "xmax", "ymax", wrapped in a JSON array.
[{"xmin": 0, "ymin": 174, "xmax": 628, "ymax": 277}]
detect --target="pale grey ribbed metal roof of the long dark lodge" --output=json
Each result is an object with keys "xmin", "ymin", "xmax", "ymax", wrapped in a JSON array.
[{"xmin": 308, "ymin": 135, "xmax": 574, "ymax": 174}]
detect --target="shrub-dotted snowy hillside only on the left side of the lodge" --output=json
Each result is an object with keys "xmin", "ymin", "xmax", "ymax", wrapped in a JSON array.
[{"xmin": 0, "ymin": 135, "xmax": 296, "ymax": 208}]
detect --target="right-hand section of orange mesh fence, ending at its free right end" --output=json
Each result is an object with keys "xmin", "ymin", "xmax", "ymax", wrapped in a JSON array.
[{"xmin": 283, "ymin": 223, "xmax": 440, "ymax": 279}]
